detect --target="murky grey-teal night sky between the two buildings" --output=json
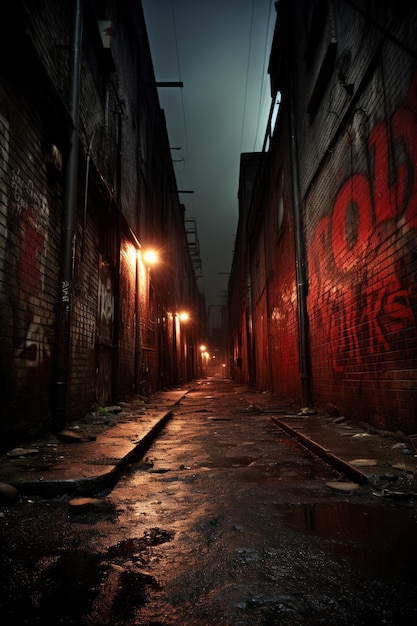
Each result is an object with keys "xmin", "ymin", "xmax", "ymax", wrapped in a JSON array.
[{"xmin": 142, "ymin": 0, "xmax": 275, "ymax": 327}]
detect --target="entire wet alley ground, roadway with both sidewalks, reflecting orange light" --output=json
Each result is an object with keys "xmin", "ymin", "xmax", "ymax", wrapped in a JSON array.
[{"xmin": 0, "ymin": 379, "xmax": 417, "ymax": 626}]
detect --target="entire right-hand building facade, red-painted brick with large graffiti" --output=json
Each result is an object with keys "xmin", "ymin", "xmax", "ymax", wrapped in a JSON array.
[{"xmin": 229, "ymin": 0, "xmax": 417, "ymax": 434}]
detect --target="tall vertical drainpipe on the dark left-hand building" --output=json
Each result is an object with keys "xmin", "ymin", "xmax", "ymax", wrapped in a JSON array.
[{"xmin": 54, "ymin": 0, "xmax": 83, "ymax": 428}]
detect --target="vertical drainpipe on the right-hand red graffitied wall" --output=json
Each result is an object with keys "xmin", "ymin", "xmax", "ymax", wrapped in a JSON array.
[{"xmin": 287, "ymin": 44, "xmax": 311, "ymax": 407}]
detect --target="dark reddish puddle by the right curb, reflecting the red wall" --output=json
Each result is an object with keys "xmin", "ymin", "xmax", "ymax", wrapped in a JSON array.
[{"xmin": 284, "ymin": 502, "xmax": 417, "ymax": 580}]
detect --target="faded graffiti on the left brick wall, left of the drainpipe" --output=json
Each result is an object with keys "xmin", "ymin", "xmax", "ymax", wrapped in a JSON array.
[{"xmin": 5, "ymin": 169, "xmax": 51, "ymax": 368}]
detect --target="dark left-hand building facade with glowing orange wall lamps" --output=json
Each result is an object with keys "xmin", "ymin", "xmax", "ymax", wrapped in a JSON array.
[{"xmin": 0, "ymin": 0, "xmax": 205, "ymax": 445}]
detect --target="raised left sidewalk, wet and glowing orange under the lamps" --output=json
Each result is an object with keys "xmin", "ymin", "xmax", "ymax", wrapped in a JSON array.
[{"xmin": 0, "ymin": 389, "xmax": 188, "ymax": 495}]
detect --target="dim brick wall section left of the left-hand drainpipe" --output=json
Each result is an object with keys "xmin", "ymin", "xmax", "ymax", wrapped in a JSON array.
[{"xmin": 0, "ymin": 82, "xmax": 61, "ymax": 437}]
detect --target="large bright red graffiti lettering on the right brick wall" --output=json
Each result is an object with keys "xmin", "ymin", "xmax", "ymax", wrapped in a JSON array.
[{"xmin": 308, "ymin": 72, "xmax": 417, "ymax": 373}]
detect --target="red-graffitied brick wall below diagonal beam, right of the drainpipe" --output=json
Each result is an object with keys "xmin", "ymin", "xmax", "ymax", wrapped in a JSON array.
[{"xmin": 306, "ymin": 60, "xmax": 417, "ymax": 432}]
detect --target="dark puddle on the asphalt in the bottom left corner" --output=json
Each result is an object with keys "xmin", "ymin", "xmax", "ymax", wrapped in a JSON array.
[{"xmin": 0, "ymin": 528, "xmax": 174, "ymax": 624}]
